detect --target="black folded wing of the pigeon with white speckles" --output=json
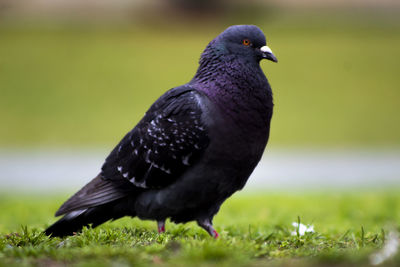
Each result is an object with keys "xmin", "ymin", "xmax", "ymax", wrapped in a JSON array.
[{"xmin": 101, "ymin": 86, "xmax": 209, "ymax": 189}]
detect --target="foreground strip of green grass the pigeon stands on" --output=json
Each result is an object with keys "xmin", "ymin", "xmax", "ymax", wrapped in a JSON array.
[{"xmin": 0, "ymin": 191, "xmax": 400, "ymax": 266}]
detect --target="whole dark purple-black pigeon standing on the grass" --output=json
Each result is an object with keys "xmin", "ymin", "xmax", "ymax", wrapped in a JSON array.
[{"xmin": 45, "ymin": 25, "xmax": 277, "ymax": 238}]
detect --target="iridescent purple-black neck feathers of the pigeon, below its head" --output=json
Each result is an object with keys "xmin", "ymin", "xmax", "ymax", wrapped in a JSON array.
[{"xmin": 190, "ymin": 47, "xmax": 273, "ymax": 135}]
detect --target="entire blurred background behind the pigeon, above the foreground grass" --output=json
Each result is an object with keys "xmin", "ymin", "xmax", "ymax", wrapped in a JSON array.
[{"xmin": 0, "ymin": 0, "xmax": 400, "ymax": 193}]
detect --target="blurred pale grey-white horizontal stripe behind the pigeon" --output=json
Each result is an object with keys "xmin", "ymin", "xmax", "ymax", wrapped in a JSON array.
[{"xmin": 0, "ymin": 150, "xmax": 400, "ymax": 192}]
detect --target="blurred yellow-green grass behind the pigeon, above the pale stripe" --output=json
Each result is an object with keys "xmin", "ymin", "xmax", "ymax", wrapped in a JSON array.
[{"xmin": 0, "ymin": 12, "xmax": 400, "ymax": 147}]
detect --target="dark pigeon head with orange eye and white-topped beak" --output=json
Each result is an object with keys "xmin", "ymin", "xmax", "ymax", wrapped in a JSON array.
[{"xmin": 210, "ymin": 25, "xmax": 278, "ymax": 62}]
